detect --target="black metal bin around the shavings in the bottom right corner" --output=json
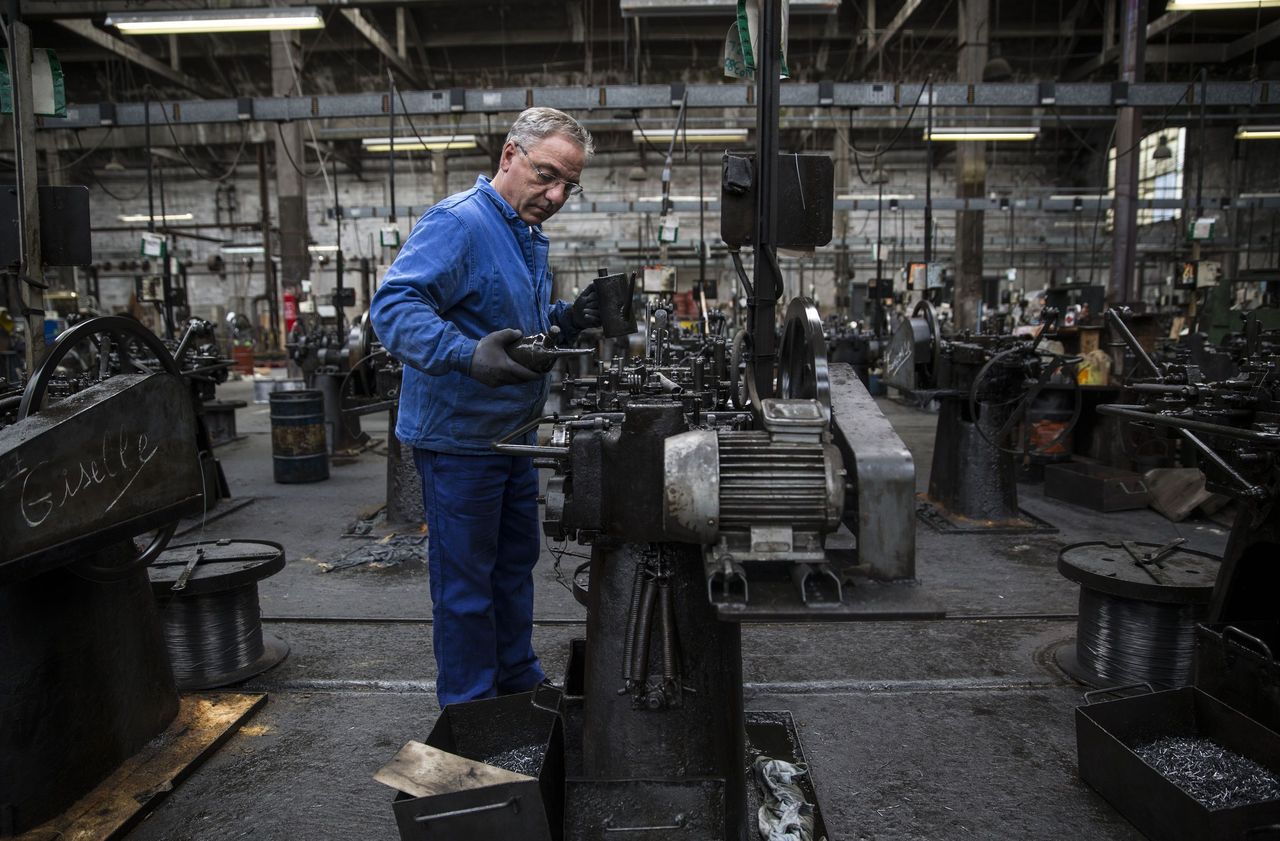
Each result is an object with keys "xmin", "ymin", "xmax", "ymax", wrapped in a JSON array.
[{"xmin": 1075, "ymin": 686, "xmax": 1280, "ymax": 841}]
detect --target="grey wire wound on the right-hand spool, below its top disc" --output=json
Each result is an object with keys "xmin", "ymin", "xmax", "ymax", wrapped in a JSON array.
[{"xmin": 1075, "ymin": 586, "xmax": 1207, "ymax": 687}]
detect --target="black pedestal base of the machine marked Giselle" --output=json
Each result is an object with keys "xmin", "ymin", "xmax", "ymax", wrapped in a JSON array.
[{"xmin": 0, "ymin": 537, "xmax": 181, "ymax": 833}]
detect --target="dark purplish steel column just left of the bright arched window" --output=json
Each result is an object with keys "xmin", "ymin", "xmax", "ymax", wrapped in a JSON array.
[{"xmin": 1107, "ymin": 0, "xmax": 1147, "ymax": 305}]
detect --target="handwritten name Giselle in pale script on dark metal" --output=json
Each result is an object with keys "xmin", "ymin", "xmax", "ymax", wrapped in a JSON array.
[{"xmin": 15, "ymin": 426, "xmax": 160, "ymax": 529}]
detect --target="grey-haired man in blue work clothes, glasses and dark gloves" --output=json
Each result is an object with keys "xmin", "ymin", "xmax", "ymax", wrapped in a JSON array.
[{"xmin": 371, "ymin": 108, "xmax": 600, "ymax": 707}]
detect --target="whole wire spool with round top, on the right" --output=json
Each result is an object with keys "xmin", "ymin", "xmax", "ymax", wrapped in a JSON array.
[{"xmin": 1057, "ymin": 540, "xmax": 1219, "ymax": 687}]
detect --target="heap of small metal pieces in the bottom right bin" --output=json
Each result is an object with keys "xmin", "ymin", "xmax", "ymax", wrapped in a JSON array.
[{"xmin": 1134, "ymin": 736, "xmax": 1280, "ymax": 812}]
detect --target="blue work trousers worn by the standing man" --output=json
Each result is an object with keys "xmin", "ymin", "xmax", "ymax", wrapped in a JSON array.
[{"xmin": 413, "ymin": 448, "xmax": 545, "ymax": 708}]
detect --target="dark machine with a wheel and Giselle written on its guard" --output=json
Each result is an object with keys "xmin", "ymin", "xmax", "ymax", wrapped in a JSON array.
[{"xmin": 0, "ymin": 317, "xmax": 205, "ymax": 836}]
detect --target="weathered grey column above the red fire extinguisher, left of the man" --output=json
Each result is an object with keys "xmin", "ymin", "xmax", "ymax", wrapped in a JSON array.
[{"xmin": 271, "ymin": 32, "xmax": 311, "ymax": 314}]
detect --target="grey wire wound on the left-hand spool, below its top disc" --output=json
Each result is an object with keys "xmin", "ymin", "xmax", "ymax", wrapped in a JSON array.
[{"xmin": 161, "ymin": 584, "xmax": 264, "ymax": 687}]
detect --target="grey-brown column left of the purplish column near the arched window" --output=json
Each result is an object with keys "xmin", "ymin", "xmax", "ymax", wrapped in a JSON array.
[{"xmin": 954, "ymin": 0, "xmax": 991, "ymax": 329}]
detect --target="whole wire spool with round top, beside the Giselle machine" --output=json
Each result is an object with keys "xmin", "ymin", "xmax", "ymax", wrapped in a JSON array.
[{"xmin": 148, "ymin": 540, "xmax": 289, "ymax": 690}]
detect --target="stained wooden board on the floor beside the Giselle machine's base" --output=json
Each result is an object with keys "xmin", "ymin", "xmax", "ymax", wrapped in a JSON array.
[{"xmin": 15, "ymin": 693, "xmax": 266, "ymax": 841}]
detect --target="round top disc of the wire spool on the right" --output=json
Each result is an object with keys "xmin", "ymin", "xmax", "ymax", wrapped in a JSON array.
[{"xmin": 1057, "ymin": 540, "xmax": 1221, "ymax": 604}]
